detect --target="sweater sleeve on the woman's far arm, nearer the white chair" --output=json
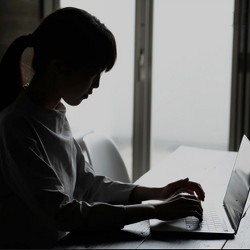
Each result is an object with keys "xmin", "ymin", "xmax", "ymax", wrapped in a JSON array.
[{"xmin": 74, "ymin": 141, "xmax": 137, "ymax": 205}]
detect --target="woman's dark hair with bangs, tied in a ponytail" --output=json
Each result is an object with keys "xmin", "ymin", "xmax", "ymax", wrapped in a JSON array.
[{"xmin": 0, "ymin": 7, "xmax": 116, "ymax": 111}]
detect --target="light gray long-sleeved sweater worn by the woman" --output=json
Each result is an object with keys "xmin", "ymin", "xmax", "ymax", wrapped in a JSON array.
[{"xmin": 0, "ymin": 90, "xmax": 135, "ymax": 247}]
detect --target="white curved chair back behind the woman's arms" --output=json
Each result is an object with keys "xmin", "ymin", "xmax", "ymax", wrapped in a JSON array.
[{"xmin": 77, "ymin": 132, "xmax": 131, "ymax": 183}]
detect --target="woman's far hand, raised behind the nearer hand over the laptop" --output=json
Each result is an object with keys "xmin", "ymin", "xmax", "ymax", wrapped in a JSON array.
[{"xmin": 160, "ymin": 178, "xmax": 205, "ymax": 201}]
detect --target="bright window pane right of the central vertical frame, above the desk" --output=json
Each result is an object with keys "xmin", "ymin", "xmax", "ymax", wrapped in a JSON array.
[{"xmin": 151, "ymin": 0, "xmax": 234, "ymax": 167}]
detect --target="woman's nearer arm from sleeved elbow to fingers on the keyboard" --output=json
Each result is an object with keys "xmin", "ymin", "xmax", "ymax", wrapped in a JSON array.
[{"xmin": 56, "ymin": 187, "xmax": 202, "ymax": 231}]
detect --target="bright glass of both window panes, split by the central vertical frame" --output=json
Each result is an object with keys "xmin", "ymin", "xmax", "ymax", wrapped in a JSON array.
[{"xmin": 61, "ymin": 0, "xmax": 234, "ymax": 177}]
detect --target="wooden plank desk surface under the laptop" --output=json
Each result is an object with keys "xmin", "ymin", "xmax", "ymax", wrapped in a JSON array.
[{"xmin": 58, "ymin": 146, "xmax": 250, "ymax": 249}]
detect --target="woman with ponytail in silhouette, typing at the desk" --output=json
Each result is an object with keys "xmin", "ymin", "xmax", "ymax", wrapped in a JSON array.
[{"xmin": 0, "ymin": 8, "xmax": 205, "ymax": 248}]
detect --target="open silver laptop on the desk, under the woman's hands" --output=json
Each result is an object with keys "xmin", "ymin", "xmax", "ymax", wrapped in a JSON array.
[{"xmin": 149, "ymin": 135, "xmax": 250, "ymax": 238}]
